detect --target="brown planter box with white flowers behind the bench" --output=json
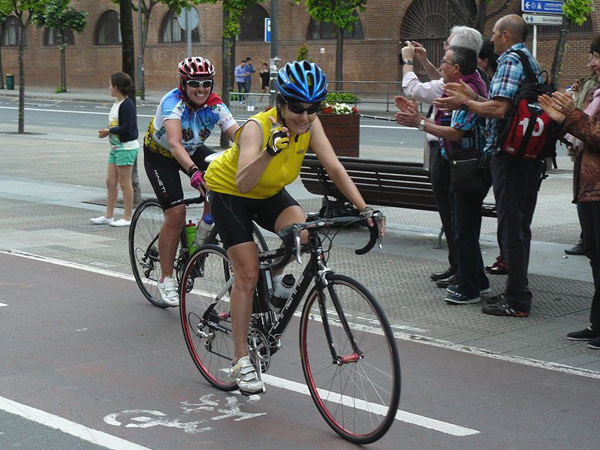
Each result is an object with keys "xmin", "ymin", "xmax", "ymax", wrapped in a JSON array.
[{"xmin": 318, "ymin": 102, "xmax": 360, "ymax": 157}]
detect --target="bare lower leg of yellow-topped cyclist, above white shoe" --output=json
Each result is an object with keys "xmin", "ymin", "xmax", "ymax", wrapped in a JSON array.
[{"xmin": 227, "ymin": 242, "xmax": 258, "ymax": 363}]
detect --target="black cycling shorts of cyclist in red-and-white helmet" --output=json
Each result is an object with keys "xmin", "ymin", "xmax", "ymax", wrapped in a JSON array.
[{"xmin": 144, "ymin": 145, "xmax": 214, "ymax": 210}]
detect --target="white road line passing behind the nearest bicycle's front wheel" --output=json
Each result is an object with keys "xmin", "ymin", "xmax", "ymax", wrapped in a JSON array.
[{"xmin": 262, "ymin": 373, "xmax": 479, "ymax": 436}]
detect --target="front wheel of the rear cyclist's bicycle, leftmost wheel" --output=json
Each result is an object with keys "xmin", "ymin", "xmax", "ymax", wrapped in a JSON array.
[{"xmin": 129, "ymin": 199, "xmax": 168, "ymax": 308}]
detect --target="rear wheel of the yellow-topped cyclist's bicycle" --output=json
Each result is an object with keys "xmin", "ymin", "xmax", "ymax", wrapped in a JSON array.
[{"xmin": 179, "ymin": 245, "xmax": 237, "ymax": 391}]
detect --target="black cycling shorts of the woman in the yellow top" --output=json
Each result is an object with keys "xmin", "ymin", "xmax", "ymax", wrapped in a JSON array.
[{"xmin": 209, "ymin": 189, "xmax": 300, "ymax": 249}]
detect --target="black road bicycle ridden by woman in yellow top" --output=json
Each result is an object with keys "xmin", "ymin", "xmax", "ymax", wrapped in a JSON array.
[{"xmin": 180, "ymin": 213, "xmax": 401, "ymax": 444}]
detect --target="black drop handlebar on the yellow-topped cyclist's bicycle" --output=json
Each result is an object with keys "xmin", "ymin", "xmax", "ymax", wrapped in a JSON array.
[{"xmin": 271, "ymin": 211, "xmax": 385, "ymax": 270}]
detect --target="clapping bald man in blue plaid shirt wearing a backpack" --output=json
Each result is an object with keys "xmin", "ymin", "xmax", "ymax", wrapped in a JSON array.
[{"xmin": 435, "ymin": 14, "xmax": 544, "ymax": 317}]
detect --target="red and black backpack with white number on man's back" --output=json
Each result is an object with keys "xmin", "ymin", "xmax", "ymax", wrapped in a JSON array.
[{"xmin": 498, "ymin": 50, "xmax": 560, "ymax": 160}]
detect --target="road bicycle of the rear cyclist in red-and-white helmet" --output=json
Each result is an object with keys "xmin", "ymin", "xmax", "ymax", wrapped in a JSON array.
[{"xmin": 129, "ymin": 196, "xmax": 268, "ymax": 308}]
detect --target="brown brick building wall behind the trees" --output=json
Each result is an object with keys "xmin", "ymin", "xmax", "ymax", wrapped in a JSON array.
[{"xmin": 0, "ymin": 0, "xmax": 600, "ymax": 90}]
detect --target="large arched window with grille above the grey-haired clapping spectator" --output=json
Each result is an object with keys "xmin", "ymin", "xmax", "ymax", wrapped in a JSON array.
[{"xmin": 399, "ymin": 0, "xmax": 457, "ymax": 80}]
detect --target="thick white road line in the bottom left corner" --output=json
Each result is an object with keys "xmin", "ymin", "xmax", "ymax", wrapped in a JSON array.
[{"xmin": 0, "ymin": 397, "xmax": 150, "ymax": 450}]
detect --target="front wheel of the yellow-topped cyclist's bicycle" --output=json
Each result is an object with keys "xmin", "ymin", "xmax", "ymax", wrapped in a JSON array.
[{"xmin": 300, "ymin": 274, "xmax": 400, "ymax": 444}]
